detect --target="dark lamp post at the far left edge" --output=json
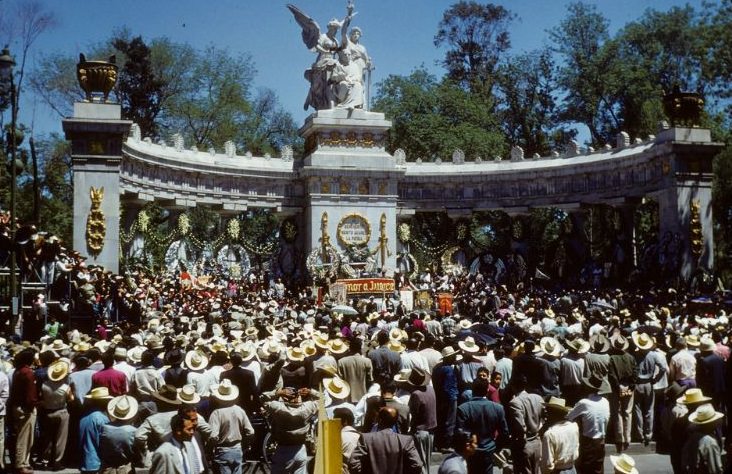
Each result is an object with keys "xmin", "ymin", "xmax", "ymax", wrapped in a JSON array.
[{"xmin": 0, "ymin": 47, "xmax": 20, "ymax": 317}]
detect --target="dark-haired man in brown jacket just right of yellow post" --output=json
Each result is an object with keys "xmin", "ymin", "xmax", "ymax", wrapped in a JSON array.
[{"xmin": 348, "ymin": 407, "xmax": 422, "ymax": 474}]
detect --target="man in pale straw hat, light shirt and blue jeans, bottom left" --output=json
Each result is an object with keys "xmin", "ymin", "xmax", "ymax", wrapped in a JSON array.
[{"xmin": 208, "ymin": 379, "xmax": 254, "ymax": 473}]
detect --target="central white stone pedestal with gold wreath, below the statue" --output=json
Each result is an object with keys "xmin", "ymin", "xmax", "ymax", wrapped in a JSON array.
[{"xmin": 300, "ymin": 109, "xmax": 405, "ymax": 276}]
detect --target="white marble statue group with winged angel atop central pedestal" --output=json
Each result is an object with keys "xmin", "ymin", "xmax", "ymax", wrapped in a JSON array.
[{"xmin": 287, "ymin": 1, "xmax": 372, "ymax": 110}]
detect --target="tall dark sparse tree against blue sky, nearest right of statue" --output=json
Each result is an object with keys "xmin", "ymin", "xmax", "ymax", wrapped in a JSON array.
[{"xmin": 434, "ymin": 1, "xmax": 515, "ymax": 94}]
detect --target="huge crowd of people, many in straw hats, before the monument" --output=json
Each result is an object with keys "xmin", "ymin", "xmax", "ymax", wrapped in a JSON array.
[{"xmin": 0, "ymin": 237, "xmax": 732, "ymax": 474}]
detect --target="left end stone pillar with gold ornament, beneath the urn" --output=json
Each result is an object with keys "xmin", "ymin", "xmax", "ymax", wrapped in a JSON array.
[{"xmin": 63, "ymin": 102, "xmax": 132, "ymax": 273}]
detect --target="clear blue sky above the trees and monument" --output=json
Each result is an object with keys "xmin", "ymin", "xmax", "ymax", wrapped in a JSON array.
[{"xmin": 0, "ymin": 0, "xmax": 702, "ymax": 143}]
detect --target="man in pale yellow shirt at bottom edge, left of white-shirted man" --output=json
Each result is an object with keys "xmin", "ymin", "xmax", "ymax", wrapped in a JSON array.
[{"xmin": 541, "ymin": 397, "xmax": 579, "ymax": 472}]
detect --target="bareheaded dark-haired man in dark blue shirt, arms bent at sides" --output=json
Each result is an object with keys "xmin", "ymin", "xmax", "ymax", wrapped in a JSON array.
[{"xmin": 455, "ymin": 377, "xmax": 509, "ymax": 473}]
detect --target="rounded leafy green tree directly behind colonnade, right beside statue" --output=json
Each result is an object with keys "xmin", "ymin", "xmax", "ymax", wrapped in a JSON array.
[{"xmin": 373, "ymin": 68, "xmax": 506, "ymax": 160}]
